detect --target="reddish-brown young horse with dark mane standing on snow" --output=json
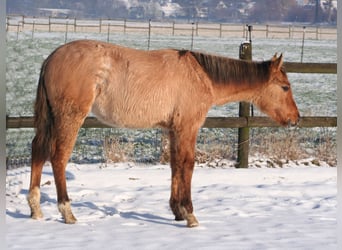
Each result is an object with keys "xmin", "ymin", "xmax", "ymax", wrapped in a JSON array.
[{"xmin": 27, "ymin": 40, "xmax": 299, "ymax": 227}]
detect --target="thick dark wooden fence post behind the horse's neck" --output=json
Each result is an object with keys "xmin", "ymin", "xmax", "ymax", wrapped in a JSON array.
[{"xmin": 236, "ymin": 25, "xmax": 252, "ymax": 168}]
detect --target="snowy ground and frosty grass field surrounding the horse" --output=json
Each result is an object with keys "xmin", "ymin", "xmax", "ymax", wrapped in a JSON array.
[{"xmin": 6, "ymin": 26, "xmax": 337, "ymax": 250}]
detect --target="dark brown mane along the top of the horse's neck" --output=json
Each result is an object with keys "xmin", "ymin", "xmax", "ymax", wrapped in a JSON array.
[{"xmin": 178, "ymin": 50, "xmax": 271, "ymax": 84}]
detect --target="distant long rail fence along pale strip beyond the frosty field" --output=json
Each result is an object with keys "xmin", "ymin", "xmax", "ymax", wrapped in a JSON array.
[{"xmin": 6, "ymin": 16, "xmax": 337, "ymax": 40}]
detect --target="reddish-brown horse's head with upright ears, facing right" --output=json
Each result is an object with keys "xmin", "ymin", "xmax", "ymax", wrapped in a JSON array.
[{"xmin": 254, "ymin": 54, "xmax": 299, "ymax": 126}]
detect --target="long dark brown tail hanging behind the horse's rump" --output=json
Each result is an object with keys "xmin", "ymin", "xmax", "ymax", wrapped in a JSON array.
[{"xmin": 32, "ymin": 58, "xmax": 54, "ymax": 162}]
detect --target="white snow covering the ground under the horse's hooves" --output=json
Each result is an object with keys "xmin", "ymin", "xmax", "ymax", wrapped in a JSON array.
[{"xmin": 6, "ymin": 163, "xmax": 337, "ymax": 250}]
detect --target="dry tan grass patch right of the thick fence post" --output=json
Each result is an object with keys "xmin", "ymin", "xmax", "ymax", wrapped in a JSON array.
[{"xmin": 250, "ymin": 128, "xmax": 337, "ymax": 166}]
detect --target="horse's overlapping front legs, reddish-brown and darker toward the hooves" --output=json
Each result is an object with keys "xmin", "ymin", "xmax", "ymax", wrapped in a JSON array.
[{"xmin": 170, "ymin": 128, "xmax": 198, "ymax": 227}]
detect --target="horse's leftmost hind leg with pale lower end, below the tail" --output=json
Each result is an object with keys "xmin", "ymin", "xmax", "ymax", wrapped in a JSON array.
[{"xmin": 27, "ymin": 136, "xmax": 46, "ymax": 219}]
